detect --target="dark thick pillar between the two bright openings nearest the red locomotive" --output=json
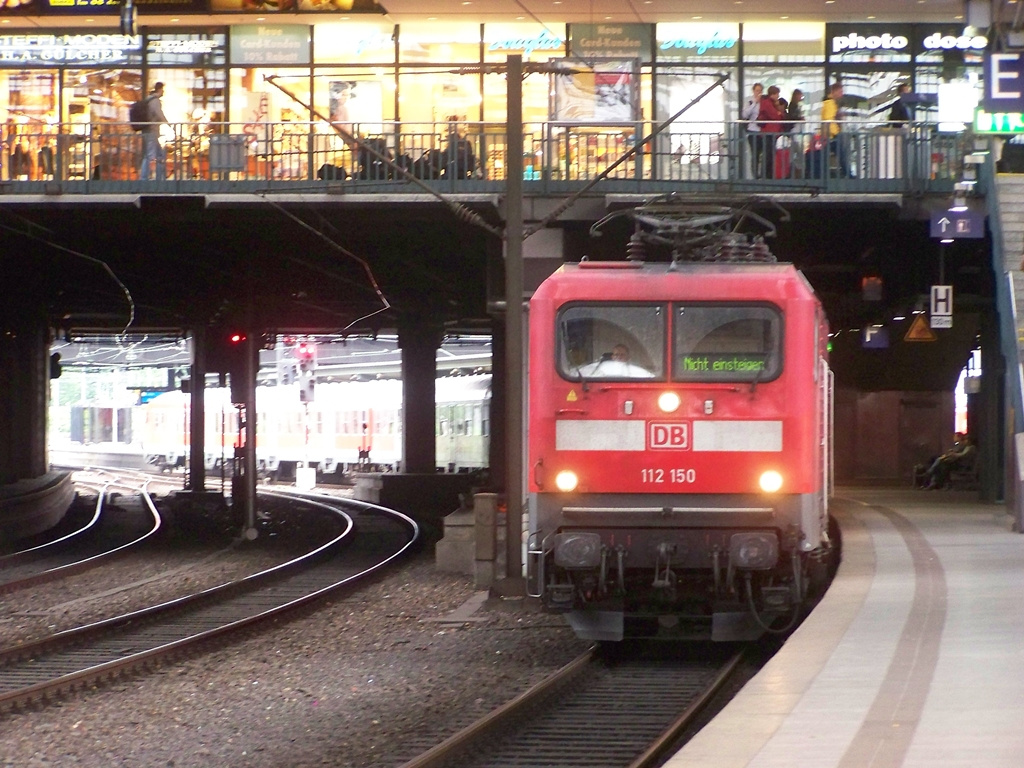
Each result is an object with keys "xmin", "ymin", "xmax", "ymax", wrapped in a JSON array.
[{"xmin": 398, "ymin": 321, "xmax": 442, "ymax": 474}]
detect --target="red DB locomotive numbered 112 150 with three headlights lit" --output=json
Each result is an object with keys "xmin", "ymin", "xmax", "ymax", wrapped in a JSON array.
[{"xmin": 527, "ymin": 211, "xmax": 831, "ymax": 640}]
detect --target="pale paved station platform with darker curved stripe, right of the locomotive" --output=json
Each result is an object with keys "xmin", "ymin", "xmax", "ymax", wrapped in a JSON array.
[{"xmin": 665, "ymin": 488, "xmax": 1024, "ymax": 768}]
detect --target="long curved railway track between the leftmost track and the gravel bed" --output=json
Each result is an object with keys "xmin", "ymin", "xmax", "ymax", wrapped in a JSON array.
[{"xmin": 0, "ymin": 493, "xmax": 418, "ymax": 712}]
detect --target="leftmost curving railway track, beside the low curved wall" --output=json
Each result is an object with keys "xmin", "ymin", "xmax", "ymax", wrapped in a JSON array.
[{"xmin": 0, "ymin": 478, "xmax": 162, "ymax": 594}]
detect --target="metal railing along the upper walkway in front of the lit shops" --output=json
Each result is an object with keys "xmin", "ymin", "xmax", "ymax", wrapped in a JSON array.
[{"xmin": 0, "ymin": 121, "xmax": 972, "ymax": 195}]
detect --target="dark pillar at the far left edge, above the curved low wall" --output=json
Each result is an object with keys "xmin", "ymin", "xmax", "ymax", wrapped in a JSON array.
[{"xmin": 0, "ymin": 312, "xmax": 50, "ymax": 485}]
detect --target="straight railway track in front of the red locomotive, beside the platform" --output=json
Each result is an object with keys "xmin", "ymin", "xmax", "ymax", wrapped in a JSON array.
[{"xmin": 402, "ymin": 644, "xmax": 743, "ymax": 768}]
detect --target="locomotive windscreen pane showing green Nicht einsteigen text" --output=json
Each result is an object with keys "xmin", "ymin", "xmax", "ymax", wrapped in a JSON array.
[{"xmin": 673, "ymin": 304, "xmax": 782, "ymax": 382}]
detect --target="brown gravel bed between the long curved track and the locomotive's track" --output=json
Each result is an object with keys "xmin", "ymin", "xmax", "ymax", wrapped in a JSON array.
[{"xmin": 0, "ymin": 554, "xmax": 588, "ymax": 768}]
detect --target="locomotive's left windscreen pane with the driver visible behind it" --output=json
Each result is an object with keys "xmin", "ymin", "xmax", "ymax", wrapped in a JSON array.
[{"xmin": 555, "ymin": 303, "xmax": 668, "ymax": 381}]
